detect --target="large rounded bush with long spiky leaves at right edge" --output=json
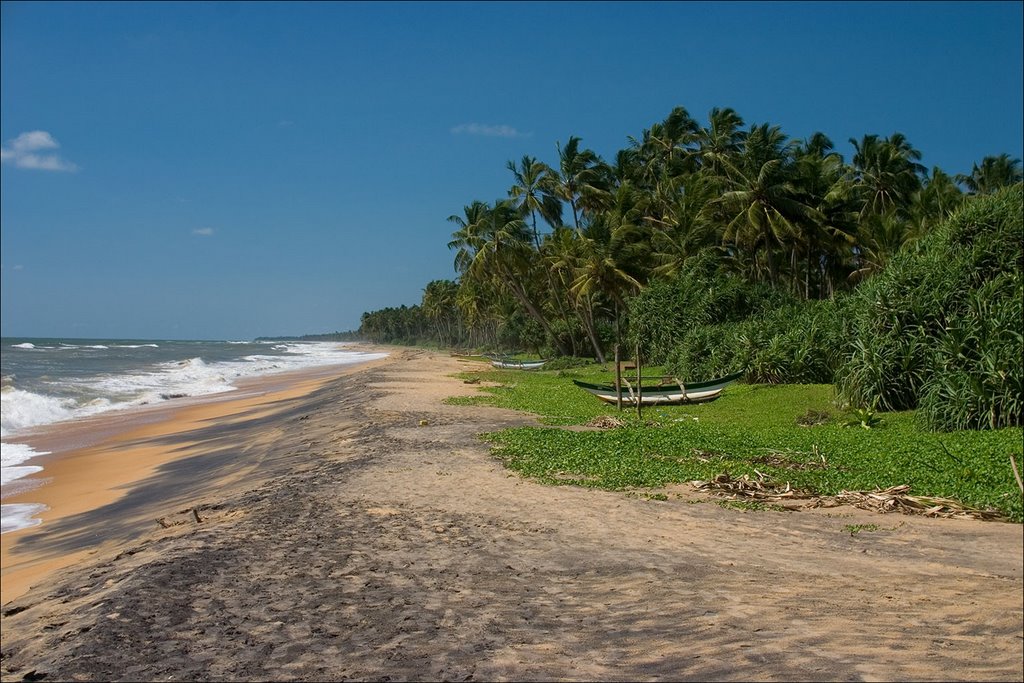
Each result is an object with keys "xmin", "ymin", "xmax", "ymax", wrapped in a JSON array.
[{"xmin": 837, "ymin": 184, "xmax": 1024, "ymax": 430}]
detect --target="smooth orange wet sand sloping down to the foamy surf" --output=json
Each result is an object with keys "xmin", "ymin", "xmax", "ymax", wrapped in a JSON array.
[{"xmin": 0, "ymin": 360, "xmax": 391, "ymax": 604}]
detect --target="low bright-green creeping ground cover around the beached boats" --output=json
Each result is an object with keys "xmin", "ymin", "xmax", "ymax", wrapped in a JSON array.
[{"xmin": 449, "ymin": 366, "xmax": 1024, "ymax": 522}]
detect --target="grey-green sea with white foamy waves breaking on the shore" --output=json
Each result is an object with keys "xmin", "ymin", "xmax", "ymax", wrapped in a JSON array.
[{"xmin": 0, "ymin": 337, "xmax": 386, "ymax": 532}]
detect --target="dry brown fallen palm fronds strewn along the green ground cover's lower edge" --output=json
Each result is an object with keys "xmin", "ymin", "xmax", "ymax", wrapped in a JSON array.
[{"xmin": 690, "ymin": 471, "xmax": 1006, "ymax": 519}]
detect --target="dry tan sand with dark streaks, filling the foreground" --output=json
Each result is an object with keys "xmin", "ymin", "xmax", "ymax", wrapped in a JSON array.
[{"xmin": 0, "ymin": 351, "xmax": 1024, "ymax": 681}]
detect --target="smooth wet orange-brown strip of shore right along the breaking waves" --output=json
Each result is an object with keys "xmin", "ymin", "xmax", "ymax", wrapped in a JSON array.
[{"xmin": 0, "ymin": 350, "xmax": 387, "ymax": 604}]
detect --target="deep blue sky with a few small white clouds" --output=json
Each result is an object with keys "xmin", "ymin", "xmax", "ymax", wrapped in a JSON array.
[{"xmin": 0, "ymin": 2, "xmax": 1024, "ymax": 339}]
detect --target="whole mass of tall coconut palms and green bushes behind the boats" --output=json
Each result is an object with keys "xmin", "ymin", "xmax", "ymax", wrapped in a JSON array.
[{"xmin": 350, "ymin": 102, "xmax": 1022, "ymax": 429}]
